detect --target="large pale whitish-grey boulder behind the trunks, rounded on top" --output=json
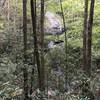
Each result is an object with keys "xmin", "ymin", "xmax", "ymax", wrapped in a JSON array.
[{"xmin": 44, "ymin": 11, "xmax": 66, "ymax": 35}]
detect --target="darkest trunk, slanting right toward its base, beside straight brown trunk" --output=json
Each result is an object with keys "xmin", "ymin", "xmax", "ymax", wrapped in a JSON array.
[{"xmin": 31, "ymin": 0, "xmax": 41, "ymax": 94}]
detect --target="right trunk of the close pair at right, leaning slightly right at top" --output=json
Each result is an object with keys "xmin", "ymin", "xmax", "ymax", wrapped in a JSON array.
[{"xmin": 87, "ymin": 0, "xmax": 95, "ymax": 75}]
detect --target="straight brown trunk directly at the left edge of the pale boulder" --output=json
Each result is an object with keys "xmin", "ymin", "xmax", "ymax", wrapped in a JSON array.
[{"xmin": 40, "ymin": 0, "xmax": 45, "ymax": 91}]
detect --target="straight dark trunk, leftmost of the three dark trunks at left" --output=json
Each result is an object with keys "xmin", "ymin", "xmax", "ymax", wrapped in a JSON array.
[{"xmin": 23, "ymin": 0, "xmax": 28, "ymax": 100}]
